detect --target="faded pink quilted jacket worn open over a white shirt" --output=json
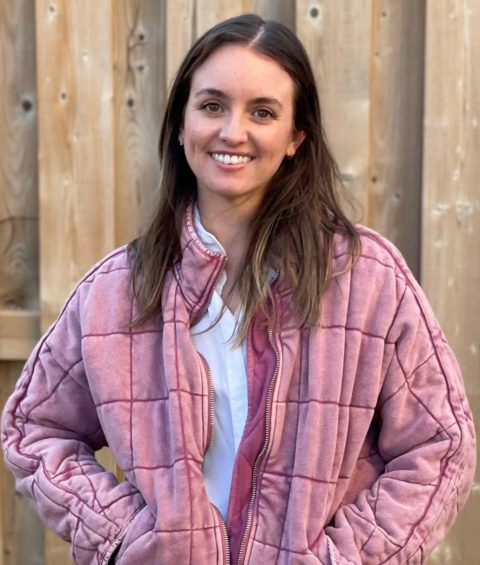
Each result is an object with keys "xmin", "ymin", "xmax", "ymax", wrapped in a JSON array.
[{"xmin": 3, "ymin": 209, "xmax": 475, "ymax": 565}]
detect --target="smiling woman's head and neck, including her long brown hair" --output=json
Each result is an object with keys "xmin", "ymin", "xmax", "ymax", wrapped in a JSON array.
[{"xmin": 131, "ymin": 16, "xmax": 352, "ymax": 330}]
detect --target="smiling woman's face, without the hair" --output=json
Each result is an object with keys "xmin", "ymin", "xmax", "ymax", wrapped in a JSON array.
[{"xmin": 180, "ymin": 45, "xmax": 304, "ymax": 212}]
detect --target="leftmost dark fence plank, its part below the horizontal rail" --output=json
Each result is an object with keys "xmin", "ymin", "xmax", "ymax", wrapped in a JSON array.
[{"xmin": 0, "ymin": 361, "xmax": 44, "ymax": 565}]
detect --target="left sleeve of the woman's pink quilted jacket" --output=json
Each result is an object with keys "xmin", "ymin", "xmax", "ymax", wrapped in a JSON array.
[{"xmin": 2, "ymin": 287, "xmax": 145, "ymax": 565}]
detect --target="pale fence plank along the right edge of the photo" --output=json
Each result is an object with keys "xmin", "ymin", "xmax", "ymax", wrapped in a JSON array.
[{"xmin": 422, "ymin": 0, "xmax": 480, "ymax": 565}]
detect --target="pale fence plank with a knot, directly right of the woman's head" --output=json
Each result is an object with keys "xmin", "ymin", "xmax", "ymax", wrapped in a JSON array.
[{"xmin": 296, "ymin": 0, "xmax": 372, "ymax": 216}]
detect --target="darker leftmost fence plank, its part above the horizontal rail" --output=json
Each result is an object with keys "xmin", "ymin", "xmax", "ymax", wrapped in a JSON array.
[{"xmin": 0, "ymin": 0, "xmax": 38, "ymax": 308}]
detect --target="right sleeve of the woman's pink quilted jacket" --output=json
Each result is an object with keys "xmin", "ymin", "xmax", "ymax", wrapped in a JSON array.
[{"xmin": 320, "ymin": 267, "xmax": 475, "ymax": 563}]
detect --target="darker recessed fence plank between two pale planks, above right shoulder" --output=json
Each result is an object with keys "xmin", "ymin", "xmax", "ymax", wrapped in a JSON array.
[{"xmin": 366, "ymin": 0, "xmax": 425, "ymax": 276}]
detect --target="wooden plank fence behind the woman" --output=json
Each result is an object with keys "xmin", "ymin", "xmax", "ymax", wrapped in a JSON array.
[{"xmin": 0, "ymin": 0, "xmax": 480, "ymax": 565}]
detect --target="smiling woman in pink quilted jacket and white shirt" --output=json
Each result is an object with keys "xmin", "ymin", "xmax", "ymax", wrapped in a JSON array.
[{"xmin": 3, "ymin": 15, "xmax": 474, "ymax": 565}]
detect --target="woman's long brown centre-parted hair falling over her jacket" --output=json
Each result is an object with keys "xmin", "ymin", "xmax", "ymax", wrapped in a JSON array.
[{"xmin": 129, "ymin": 14, "xmax": 359, "ymax": 337}]
